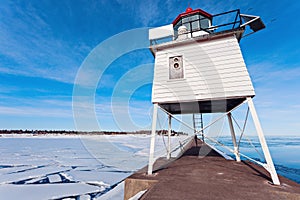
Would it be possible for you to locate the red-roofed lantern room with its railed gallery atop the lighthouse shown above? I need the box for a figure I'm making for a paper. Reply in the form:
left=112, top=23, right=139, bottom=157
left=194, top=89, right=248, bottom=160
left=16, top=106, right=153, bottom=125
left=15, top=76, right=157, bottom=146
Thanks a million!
left=149, top=7, right=265, bottom=45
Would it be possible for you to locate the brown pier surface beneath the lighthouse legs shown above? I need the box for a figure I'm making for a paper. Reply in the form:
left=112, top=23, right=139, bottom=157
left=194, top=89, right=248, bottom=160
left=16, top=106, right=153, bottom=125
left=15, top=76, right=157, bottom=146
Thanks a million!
left=124, top=141, right=300, bottom=200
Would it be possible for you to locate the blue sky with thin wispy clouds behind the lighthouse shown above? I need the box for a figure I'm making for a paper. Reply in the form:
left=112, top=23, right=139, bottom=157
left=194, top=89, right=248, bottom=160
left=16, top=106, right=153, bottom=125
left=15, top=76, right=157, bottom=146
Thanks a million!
left=0, top=0, right=300, bottom=135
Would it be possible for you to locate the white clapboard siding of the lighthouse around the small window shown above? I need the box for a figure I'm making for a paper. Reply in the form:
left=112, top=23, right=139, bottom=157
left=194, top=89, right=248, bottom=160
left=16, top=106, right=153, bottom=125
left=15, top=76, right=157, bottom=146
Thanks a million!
left=152, top=36, right=255, bottom=103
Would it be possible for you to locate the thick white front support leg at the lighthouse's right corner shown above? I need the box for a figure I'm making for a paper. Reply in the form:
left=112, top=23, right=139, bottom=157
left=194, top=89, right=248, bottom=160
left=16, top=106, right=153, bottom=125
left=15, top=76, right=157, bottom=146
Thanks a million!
left=247, top=97, right=280, bottom=185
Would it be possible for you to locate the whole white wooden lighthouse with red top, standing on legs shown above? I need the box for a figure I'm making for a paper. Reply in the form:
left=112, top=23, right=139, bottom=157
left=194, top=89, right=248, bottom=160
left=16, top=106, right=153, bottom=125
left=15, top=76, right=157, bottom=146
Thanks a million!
left=148, top=8, right=280, bottom=185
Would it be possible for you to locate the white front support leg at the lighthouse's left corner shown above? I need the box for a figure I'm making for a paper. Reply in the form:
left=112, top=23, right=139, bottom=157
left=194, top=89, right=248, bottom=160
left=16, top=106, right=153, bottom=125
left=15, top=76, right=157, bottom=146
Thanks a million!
left=148, top=103, right=158, bottom=175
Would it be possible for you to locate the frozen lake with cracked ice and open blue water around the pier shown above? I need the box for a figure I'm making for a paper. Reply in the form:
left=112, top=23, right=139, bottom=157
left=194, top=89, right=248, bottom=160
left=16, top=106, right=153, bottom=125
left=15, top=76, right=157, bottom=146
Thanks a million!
left=0, top=135, right=300, bottom=200
